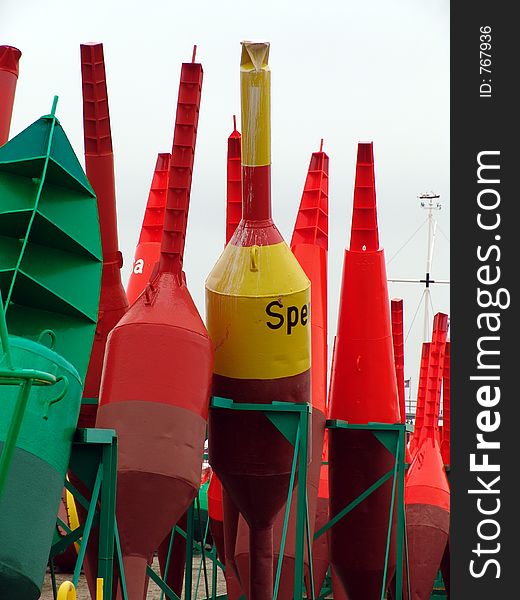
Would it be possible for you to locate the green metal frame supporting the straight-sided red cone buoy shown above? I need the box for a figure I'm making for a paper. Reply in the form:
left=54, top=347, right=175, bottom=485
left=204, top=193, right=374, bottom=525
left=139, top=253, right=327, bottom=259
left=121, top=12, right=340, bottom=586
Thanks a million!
left=314, top=419, right=413, bottom=600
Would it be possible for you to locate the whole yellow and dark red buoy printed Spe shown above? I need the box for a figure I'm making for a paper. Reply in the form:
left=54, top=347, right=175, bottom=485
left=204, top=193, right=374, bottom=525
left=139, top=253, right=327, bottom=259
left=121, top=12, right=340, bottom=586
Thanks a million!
left=206, top=42, right=311, bottom=600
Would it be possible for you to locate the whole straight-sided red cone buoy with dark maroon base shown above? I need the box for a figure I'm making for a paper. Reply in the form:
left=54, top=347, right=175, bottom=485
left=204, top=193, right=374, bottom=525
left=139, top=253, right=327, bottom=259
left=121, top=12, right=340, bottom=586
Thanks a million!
left=329, top=143, right=400, bottom=600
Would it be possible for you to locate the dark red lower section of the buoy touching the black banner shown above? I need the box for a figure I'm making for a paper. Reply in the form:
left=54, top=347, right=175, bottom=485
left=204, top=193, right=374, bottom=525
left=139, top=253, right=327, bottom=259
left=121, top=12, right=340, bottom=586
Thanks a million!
left=406, top=504, right=450, bottom=600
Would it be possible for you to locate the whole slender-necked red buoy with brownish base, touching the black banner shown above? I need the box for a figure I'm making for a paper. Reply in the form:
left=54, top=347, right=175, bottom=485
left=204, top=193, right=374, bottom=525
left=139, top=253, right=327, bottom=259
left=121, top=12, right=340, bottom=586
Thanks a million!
left=405, top=313, right=450, bottom=600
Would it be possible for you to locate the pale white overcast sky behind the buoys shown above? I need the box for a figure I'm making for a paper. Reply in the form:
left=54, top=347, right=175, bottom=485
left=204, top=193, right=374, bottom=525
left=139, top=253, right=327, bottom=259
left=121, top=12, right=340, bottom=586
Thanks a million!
left=0, top=0, right=450, bottom=404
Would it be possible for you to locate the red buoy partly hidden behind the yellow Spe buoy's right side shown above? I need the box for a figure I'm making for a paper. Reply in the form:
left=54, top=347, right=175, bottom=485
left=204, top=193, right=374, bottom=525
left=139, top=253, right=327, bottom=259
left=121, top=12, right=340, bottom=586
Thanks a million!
left=235, top=143, right=329, bottom=600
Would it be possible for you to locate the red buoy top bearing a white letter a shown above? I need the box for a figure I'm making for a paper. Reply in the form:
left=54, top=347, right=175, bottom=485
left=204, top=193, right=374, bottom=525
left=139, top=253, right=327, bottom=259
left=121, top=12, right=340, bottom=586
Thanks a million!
left=126, top=153, right=171, bottom=305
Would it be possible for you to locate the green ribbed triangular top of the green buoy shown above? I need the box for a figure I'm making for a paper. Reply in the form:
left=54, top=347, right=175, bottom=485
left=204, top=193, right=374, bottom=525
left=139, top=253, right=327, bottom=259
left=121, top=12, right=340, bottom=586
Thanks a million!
left=0, top=98, right=103, bottom=379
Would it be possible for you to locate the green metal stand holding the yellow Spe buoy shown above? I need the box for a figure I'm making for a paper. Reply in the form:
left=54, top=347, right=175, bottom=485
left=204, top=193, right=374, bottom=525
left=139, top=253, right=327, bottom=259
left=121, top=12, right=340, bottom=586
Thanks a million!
left=210, top=396, right=314, bottom=600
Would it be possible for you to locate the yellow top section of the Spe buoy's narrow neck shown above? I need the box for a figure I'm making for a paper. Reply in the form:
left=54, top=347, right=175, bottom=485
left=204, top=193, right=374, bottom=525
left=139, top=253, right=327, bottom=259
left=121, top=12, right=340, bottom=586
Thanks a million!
left=240, top=42, right=271, bottom=167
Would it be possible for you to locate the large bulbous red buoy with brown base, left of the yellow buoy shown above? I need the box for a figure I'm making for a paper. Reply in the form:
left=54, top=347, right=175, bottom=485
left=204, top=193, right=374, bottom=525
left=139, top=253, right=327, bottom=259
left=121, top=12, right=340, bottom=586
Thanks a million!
left=96, top=52, right=213, bottom=600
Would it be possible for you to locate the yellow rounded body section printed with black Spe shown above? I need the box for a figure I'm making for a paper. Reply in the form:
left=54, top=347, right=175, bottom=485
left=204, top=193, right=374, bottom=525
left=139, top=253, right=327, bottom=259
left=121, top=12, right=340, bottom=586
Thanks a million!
left=206, top=242, right=311, bottom=379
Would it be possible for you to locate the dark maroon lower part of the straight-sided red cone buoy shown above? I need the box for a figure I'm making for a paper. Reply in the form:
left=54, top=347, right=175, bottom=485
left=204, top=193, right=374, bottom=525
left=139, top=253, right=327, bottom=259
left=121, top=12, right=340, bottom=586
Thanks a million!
left=329, top=429, right=396, bottom=600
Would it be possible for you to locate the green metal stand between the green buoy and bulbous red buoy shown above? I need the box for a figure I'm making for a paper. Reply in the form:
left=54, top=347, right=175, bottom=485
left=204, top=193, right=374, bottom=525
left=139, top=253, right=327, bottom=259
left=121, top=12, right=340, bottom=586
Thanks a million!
left=49, top=429, right=121, bottom=600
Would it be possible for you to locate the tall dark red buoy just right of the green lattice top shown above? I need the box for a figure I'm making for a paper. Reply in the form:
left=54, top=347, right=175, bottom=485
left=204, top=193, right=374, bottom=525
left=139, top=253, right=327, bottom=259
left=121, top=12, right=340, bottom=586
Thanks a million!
left=78, top=44, right=128, bottom=427
